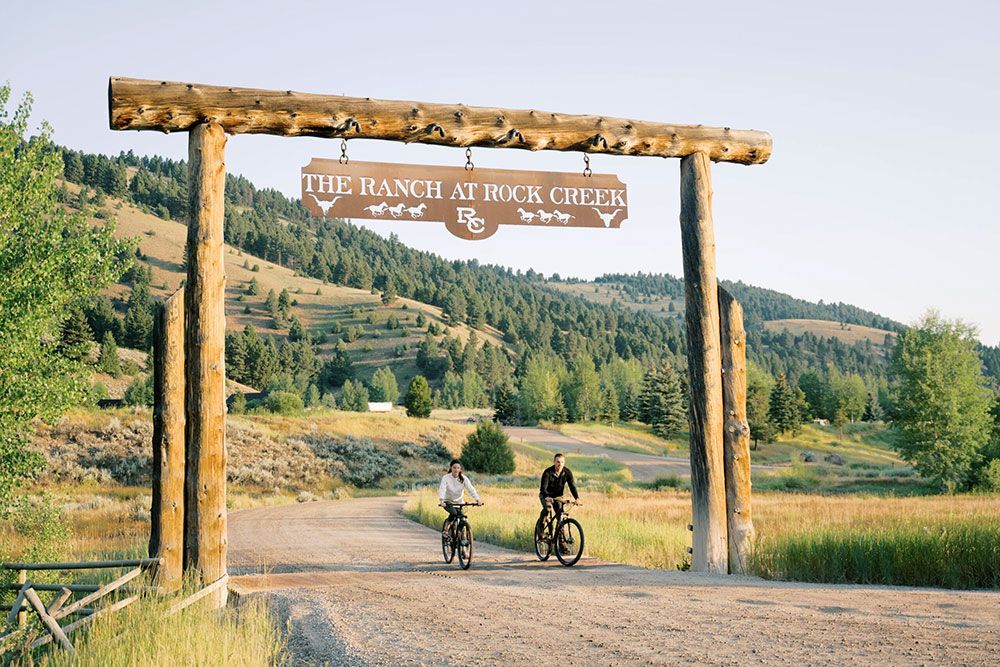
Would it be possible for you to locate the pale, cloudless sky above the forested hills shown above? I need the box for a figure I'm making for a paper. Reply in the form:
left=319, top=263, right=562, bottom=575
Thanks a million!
left=7, top=0, right=1000, bottom=345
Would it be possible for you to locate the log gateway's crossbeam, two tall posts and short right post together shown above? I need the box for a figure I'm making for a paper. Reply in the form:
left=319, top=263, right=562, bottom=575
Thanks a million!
left=108, top=77, right=771, bottom=605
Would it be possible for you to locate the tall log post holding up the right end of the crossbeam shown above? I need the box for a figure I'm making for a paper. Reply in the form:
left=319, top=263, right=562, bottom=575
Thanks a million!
left=680, top=153, right=729, bottom=574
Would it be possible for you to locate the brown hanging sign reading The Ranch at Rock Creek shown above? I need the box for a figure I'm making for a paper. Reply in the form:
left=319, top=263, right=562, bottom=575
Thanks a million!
left=302, top=158, right=628, bottom=240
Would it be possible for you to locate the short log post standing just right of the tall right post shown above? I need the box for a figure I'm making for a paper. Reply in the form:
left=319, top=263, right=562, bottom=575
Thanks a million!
left=719, top=287, right=756, bottom=574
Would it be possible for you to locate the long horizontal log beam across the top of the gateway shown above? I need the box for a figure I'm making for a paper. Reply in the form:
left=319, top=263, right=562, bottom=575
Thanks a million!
left=108, top=77, right=771, bottom=164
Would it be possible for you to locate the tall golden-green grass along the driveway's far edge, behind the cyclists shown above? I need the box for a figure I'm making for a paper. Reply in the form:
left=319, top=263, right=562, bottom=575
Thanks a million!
left=406, top=487, right=1000, bottom=588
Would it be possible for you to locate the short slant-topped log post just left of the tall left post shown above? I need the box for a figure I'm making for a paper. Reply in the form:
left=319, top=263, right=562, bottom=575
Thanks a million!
left=149, top=287, right=185, bottom=591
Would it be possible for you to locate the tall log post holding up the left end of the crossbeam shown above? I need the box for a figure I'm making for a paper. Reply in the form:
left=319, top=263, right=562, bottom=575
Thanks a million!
left=184, top=122, right=227, bottom=607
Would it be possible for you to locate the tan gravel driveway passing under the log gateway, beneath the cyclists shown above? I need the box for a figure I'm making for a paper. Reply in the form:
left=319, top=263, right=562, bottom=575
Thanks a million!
left=229, top=497, right=1000, bottom=665
